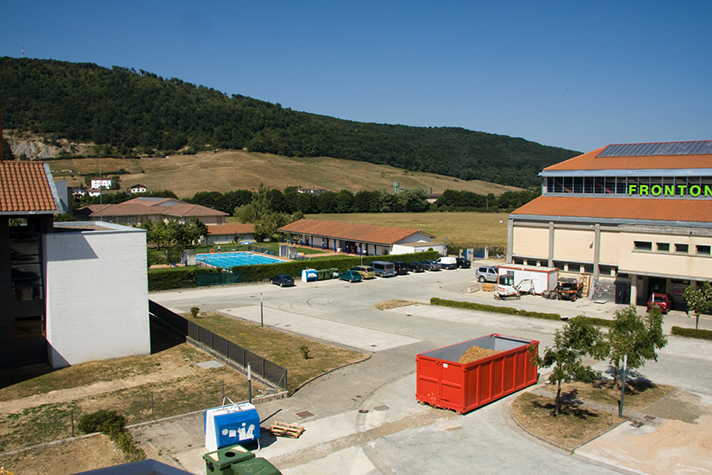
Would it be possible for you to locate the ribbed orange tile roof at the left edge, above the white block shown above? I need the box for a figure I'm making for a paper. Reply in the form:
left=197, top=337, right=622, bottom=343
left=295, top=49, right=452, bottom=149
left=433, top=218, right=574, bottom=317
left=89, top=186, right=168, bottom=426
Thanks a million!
left=0, top=161, right=59, bottom=214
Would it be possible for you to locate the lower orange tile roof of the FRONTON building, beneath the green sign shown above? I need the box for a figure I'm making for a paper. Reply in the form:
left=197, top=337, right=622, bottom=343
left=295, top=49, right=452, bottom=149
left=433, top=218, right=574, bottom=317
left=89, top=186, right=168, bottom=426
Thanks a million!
left=512, top=196, right=712, bottom=223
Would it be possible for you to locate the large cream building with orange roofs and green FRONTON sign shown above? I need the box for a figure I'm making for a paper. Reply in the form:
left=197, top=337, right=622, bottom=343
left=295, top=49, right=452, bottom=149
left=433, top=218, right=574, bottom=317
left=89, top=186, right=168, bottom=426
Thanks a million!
left=507, top=140, right=712, bottom=309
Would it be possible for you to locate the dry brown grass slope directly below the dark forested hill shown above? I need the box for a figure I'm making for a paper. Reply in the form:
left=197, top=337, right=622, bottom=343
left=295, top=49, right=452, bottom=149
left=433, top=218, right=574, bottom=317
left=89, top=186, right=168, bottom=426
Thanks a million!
left=48, top=150, right=518, bottom=198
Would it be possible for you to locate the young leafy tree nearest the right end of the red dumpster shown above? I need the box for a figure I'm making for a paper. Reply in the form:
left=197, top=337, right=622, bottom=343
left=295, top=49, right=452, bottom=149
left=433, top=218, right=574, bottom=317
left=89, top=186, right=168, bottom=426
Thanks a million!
left=536, top=317, right=609, bottom=416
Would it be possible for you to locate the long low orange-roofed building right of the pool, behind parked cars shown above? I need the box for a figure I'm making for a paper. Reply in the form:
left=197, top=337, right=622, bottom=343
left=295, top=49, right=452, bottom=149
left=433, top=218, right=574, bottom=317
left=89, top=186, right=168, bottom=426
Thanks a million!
left=279, top=219, right=447, bottom=256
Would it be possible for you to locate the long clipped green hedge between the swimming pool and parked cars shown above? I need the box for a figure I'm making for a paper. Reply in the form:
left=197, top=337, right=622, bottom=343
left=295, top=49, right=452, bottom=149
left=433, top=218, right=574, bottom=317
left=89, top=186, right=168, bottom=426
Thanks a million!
left=148, top=251, right=438, bottom=292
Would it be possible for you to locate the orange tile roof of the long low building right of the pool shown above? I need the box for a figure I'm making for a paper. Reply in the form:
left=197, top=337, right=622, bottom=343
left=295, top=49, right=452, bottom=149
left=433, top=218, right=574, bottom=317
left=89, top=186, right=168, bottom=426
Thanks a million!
left=279, top=219, right=434, bottom=244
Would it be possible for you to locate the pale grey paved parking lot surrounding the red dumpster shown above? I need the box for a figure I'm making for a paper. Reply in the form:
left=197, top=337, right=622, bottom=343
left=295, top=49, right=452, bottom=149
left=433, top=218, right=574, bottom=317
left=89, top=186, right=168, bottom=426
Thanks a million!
left=147, top=264, right=712, bottom=474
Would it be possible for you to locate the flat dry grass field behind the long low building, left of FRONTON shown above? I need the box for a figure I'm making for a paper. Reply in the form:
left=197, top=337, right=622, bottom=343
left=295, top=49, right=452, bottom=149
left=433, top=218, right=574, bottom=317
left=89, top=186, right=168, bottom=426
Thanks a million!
left=306, top=212, right=508, bottom=249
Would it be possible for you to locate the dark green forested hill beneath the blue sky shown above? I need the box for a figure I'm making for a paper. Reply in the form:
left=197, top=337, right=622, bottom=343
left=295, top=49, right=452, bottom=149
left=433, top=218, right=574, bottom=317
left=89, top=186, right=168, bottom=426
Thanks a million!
left=0, top=57, right=578, bottom=187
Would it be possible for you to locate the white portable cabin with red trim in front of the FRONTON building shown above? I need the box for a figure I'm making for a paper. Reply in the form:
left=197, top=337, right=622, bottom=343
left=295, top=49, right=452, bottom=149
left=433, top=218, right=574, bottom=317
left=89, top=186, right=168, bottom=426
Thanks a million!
left=494, top=264, right=559, bottom=299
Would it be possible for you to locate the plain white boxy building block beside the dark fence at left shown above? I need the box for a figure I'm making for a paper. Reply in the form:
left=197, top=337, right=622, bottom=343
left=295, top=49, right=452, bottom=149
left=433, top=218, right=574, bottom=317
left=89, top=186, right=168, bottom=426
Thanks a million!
left=44, top=223, right=151, bottom=368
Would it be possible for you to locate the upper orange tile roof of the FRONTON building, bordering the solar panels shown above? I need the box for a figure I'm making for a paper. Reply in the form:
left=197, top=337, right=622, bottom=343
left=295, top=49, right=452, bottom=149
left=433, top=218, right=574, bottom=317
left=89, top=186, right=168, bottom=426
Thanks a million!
left=544, top=147, right=712, bottom=172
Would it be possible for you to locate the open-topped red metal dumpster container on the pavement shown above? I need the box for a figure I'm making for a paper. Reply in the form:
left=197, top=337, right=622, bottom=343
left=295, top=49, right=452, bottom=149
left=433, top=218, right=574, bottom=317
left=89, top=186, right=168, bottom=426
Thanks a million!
left=415, top=333, right=539, bottom=414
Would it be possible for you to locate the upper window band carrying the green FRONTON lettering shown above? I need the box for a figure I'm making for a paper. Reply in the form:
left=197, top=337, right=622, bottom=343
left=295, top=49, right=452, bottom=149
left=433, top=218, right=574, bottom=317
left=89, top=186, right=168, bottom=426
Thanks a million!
left=543, top=176, right=712, bottom=198
